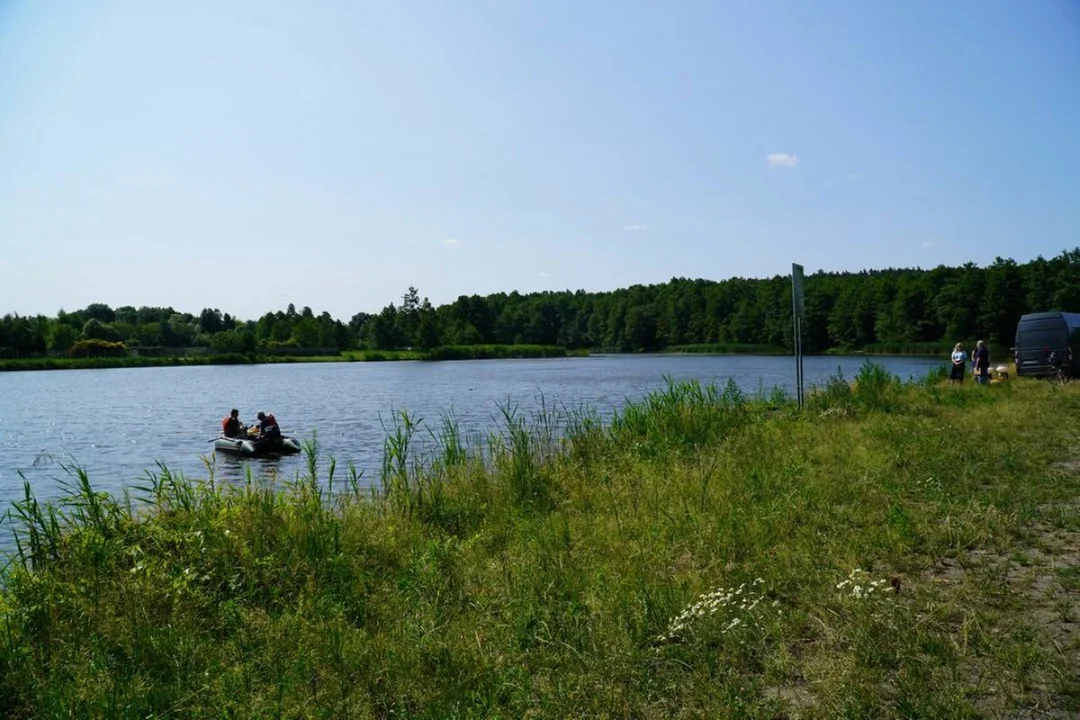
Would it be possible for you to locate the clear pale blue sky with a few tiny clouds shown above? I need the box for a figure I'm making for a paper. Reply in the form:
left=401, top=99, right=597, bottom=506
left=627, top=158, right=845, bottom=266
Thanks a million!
left=0, top=0, right=1080, bottom=318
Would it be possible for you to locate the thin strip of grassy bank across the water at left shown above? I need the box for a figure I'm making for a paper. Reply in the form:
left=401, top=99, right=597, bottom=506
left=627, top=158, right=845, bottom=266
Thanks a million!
left=0, top=345, right=589, bottom=371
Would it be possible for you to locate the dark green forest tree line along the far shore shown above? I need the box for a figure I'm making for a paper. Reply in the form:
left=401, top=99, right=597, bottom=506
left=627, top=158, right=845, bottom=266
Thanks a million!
left=0, top=248, right=1080, bottom=357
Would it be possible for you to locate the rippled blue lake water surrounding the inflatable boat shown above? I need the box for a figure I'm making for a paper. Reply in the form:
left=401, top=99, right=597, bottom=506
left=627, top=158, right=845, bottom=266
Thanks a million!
left=0, top=355, right=942, bottom=511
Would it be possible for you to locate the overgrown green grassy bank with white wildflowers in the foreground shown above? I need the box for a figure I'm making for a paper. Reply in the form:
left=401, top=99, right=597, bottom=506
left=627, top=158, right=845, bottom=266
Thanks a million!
left=0, top=366, right=1080, bottom=718
